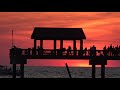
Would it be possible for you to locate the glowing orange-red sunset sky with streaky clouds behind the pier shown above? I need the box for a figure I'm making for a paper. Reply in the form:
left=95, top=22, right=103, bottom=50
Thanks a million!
left=0, top=12, right=120, bottom=67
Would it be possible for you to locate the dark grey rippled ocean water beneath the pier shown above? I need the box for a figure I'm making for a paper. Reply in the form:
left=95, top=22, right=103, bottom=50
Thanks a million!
left=0, top=66, right=120, bottom=78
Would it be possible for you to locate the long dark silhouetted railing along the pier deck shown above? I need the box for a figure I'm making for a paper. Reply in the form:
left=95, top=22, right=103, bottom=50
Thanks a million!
left=10, top=48, right=120, bottom=56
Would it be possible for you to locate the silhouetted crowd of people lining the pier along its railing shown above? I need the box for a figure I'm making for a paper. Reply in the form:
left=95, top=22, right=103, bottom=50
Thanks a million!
left=10, top=44, right=120, bottom=56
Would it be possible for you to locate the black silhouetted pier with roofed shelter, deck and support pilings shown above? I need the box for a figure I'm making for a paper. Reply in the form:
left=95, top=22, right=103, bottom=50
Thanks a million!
left=10, top=27, right=120, bottom=78
